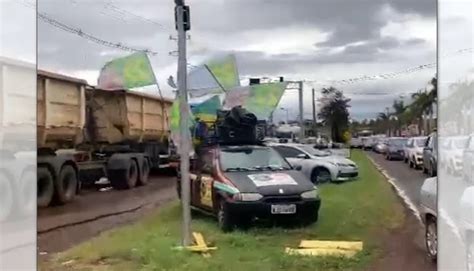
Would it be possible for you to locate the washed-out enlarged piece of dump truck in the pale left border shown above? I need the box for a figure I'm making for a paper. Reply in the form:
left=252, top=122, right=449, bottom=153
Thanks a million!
left=0, top=57, right=36, bottom=221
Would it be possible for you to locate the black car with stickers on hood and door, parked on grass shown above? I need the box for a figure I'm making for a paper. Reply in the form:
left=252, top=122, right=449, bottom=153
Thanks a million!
left=178, top=145, right=321, bottom=231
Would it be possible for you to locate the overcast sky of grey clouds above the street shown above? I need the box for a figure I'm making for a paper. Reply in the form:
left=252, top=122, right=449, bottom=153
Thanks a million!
left=38, top=0, right=436, bottom=120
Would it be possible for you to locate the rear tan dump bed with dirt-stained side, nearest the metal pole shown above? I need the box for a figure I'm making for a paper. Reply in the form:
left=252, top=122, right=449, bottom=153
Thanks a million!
left=87, top=89, right=172, bottom=144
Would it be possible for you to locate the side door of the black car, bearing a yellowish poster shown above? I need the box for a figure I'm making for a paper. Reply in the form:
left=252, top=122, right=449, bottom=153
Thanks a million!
left=191, top=149, right=215, bottom=210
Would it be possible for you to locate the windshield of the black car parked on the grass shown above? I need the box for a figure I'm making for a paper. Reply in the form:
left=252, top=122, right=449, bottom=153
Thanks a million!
left=220, top=147, right=291, bottom=171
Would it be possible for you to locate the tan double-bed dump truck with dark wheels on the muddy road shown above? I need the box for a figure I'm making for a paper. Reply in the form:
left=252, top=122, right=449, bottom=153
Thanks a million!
left=37, top=70, right=172, bottom=207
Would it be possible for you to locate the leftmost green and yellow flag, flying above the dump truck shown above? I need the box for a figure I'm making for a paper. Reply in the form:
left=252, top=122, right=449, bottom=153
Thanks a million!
left=97, top=52, right=156, bottom=90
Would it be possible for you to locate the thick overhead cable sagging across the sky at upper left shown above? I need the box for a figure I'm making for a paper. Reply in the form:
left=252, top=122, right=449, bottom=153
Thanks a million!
left=37, top=12, right=158, bottom=55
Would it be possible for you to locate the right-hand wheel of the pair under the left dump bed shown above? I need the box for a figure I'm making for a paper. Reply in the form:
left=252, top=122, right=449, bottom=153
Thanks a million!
left=54, top=165, right=78, bottom=204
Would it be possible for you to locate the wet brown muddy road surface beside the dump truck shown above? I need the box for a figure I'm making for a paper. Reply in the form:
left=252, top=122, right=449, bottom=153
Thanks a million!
left=37, top=171, right=177, bottom=256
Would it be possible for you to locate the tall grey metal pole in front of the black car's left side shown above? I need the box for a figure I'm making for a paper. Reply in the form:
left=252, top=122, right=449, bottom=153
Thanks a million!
left=176, top=1, right=191, bottom=246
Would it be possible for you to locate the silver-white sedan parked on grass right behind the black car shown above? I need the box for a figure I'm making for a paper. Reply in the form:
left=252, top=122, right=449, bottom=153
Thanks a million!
left=272, top=144, right=359, bottom=184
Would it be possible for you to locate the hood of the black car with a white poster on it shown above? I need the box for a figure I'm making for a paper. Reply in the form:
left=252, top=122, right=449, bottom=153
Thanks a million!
left=224, top=170, right=314, bottom=196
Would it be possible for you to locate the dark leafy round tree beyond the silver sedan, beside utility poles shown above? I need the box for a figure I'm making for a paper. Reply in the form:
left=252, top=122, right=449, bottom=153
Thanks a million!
left=318, top=87, right=351, bottom=142
